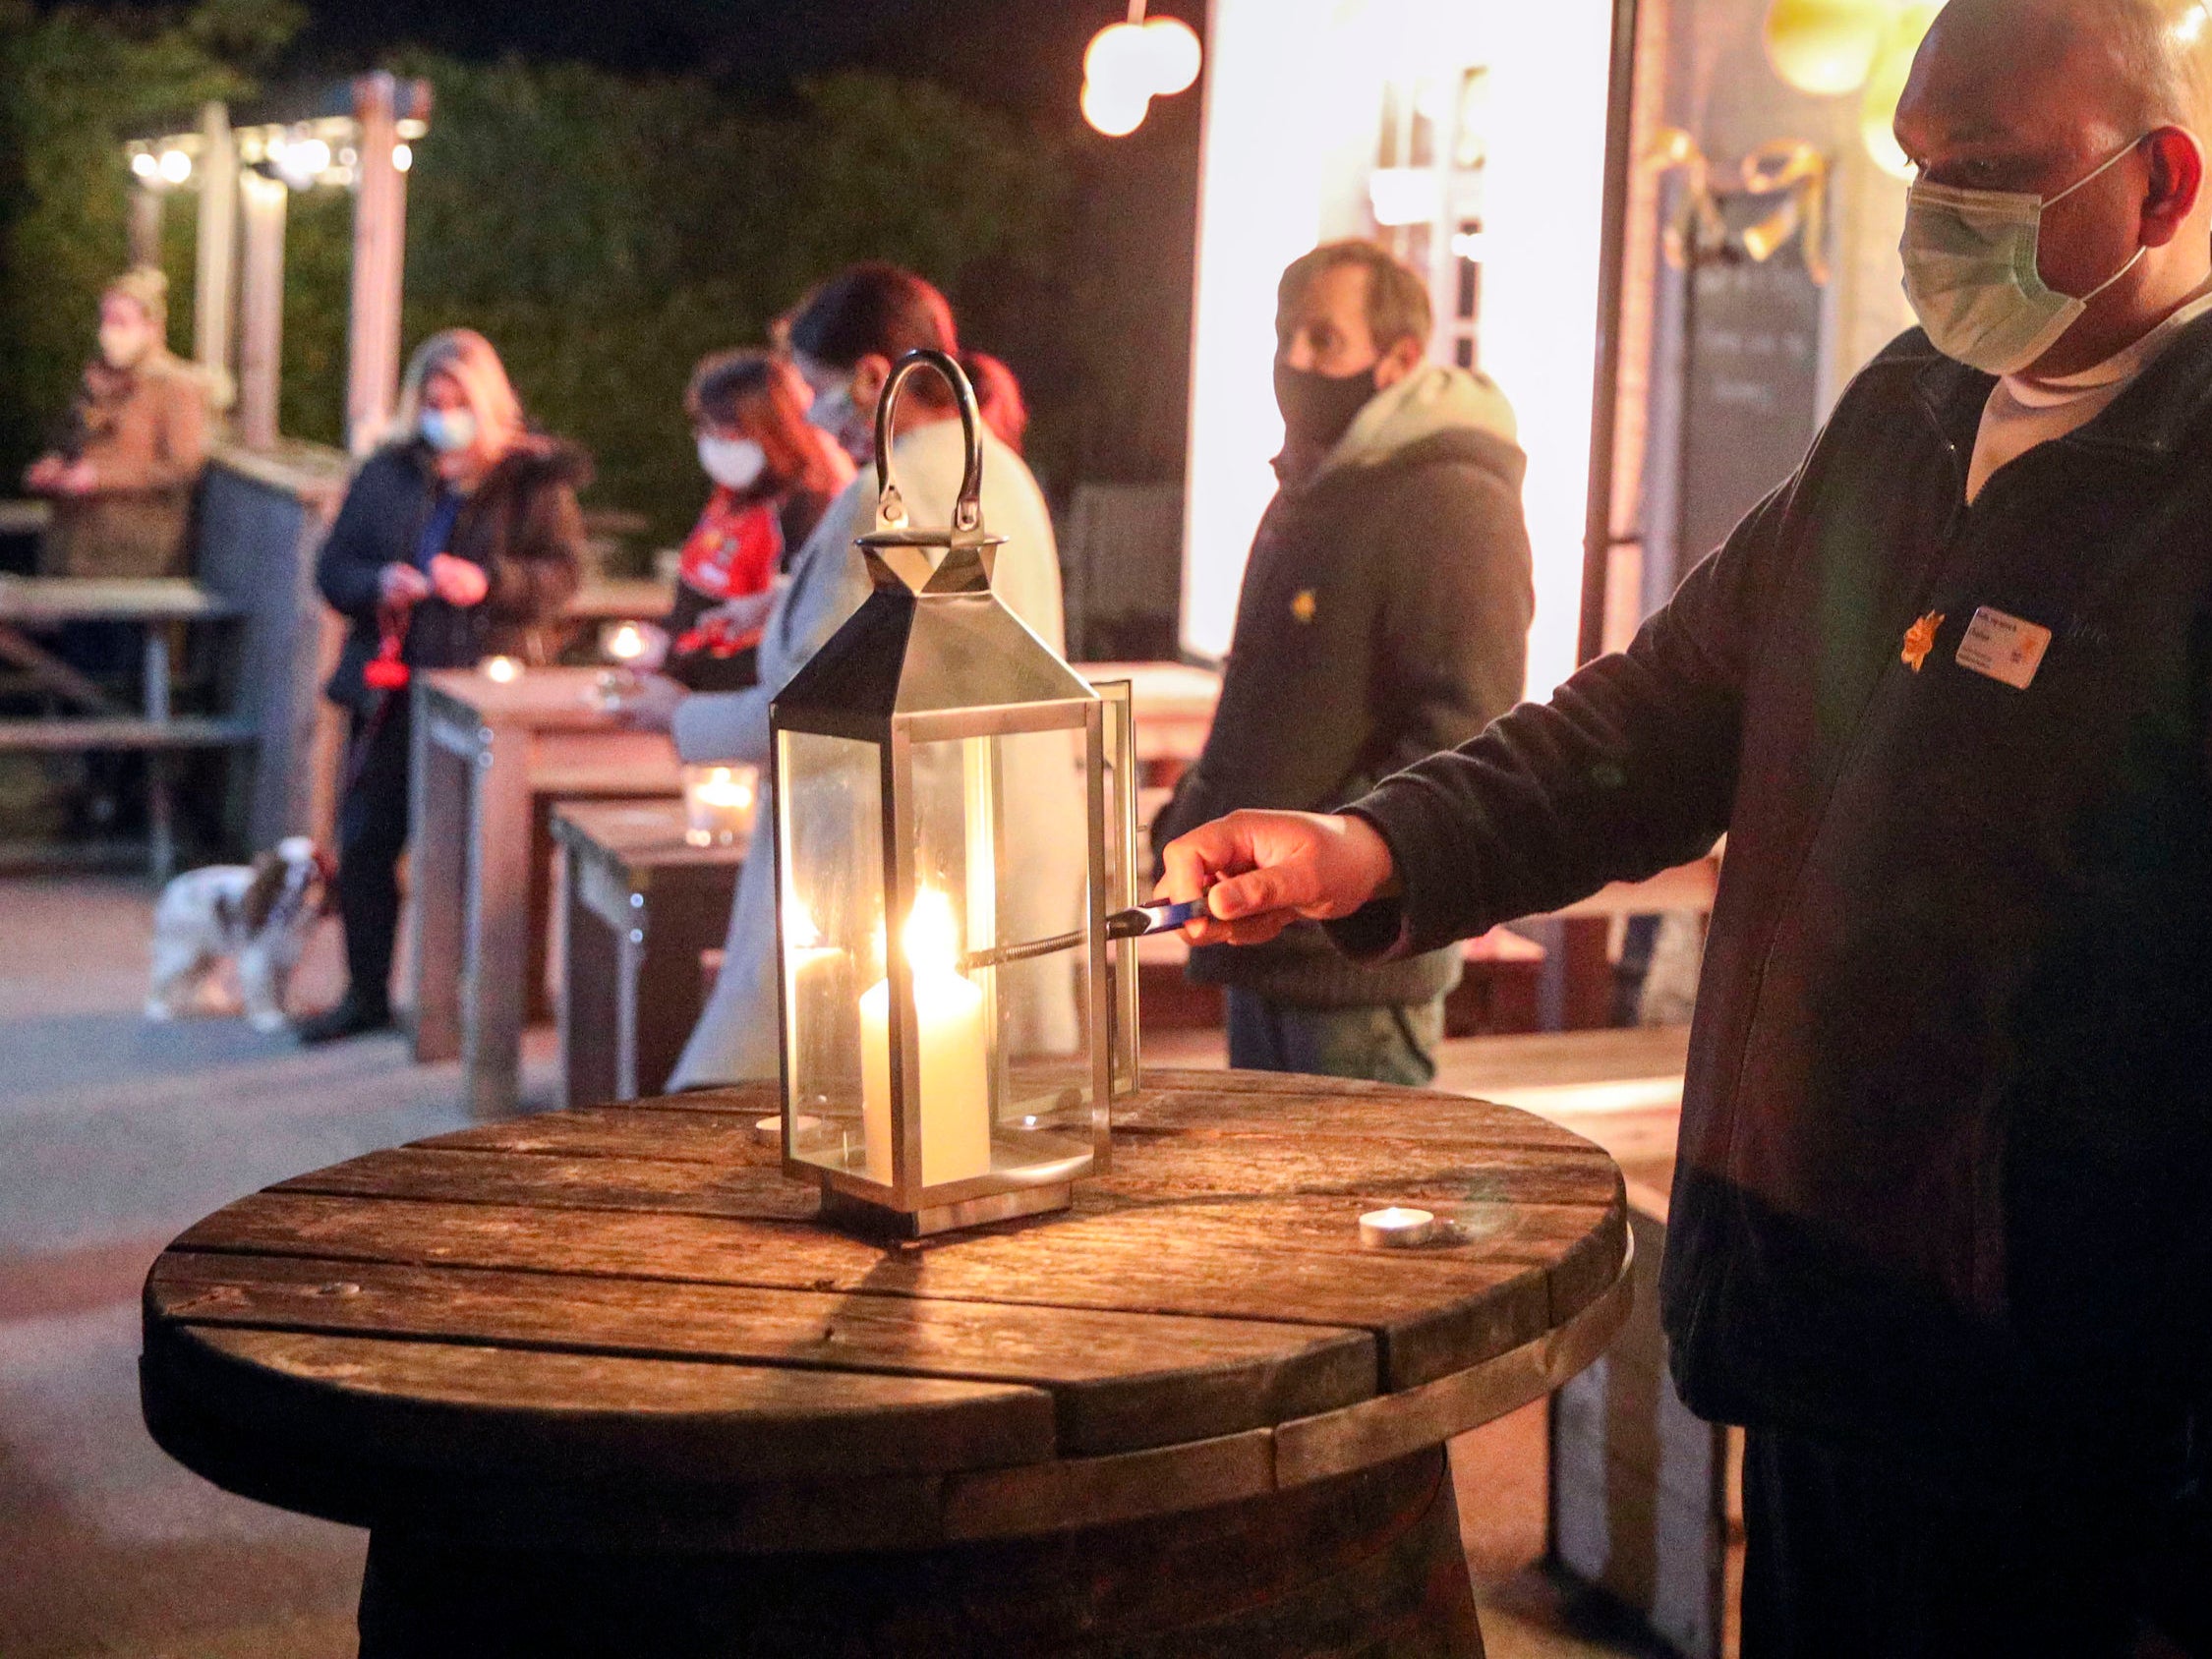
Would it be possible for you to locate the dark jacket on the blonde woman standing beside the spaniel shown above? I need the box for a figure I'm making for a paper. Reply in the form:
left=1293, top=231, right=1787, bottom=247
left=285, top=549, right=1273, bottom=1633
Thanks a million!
left=315, top=435, right=591, bottom=710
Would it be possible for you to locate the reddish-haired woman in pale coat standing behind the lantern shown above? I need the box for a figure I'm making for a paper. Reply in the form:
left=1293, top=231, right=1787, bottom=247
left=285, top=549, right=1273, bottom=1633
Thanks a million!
left=639, top=263, right=1066, bottom=1088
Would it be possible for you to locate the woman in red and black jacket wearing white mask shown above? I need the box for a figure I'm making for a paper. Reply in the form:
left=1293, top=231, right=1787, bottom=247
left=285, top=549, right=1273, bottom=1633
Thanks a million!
left=666, top=352, right=851, bottom=690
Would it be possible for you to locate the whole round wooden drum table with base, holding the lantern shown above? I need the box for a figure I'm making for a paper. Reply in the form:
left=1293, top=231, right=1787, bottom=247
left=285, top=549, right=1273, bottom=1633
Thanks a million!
left=142, top=1073, right=1628, bottom=1659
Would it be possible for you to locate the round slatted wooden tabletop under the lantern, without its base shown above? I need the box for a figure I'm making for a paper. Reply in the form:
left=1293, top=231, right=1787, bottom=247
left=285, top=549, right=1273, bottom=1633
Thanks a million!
left=146, top=1073, right=1628, bottom=1548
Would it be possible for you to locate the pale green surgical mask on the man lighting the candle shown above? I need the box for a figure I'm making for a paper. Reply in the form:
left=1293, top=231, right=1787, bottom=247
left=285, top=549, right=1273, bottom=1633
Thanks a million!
left=1900, top=140, right=2148, bottom=373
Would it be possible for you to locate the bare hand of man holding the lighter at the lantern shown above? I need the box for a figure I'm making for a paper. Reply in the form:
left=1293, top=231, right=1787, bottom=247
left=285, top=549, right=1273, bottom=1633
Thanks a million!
left=1155, top=812, right=1394, bottom=944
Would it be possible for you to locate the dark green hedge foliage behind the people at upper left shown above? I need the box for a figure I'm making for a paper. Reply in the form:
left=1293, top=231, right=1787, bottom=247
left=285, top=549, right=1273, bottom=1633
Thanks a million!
left=0, top=0, right=1071, bottom=552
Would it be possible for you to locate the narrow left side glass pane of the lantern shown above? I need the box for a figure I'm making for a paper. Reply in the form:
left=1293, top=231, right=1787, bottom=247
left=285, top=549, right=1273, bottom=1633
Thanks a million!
left=777, top=730, right=892, bottom=1181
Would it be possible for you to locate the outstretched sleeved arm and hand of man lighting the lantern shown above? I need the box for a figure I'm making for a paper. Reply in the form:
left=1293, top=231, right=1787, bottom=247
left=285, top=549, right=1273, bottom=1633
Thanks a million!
left=1159, top=486, right=1792, bottom=955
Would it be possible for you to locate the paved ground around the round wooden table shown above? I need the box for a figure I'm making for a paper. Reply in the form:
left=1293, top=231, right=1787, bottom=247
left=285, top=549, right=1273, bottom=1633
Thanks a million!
left=0, top=879, right=1646, bottom=1659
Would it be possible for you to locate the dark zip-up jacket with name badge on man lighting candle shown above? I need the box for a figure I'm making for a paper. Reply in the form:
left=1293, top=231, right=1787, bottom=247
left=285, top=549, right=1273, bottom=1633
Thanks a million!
left=1336, top=318, right=2212, bottom=1477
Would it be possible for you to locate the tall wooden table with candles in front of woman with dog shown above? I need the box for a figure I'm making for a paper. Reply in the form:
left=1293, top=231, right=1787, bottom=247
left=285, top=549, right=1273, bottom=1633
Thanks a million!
left=409, top=668, right=681, bottom=1117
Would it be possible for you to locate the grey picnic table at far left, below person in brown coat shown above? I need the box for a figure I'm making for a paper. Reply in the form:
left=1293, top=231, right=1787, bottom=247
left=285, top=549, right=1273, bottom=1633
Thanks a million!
left=0, top=575, right=255, bottom=881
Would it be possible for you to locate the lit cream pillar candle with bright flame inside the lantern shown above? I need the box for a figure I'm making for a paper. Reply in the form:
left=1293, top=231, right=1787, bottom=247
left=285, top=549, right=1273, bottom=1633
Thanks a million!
left=860, top=887, right=991, bottom=1185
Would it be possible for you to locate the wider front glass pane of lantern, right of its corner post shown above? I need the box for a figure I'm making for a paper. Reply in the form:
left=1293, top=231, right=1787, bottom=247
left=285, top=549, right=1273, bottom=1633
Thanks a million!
left=909, top=725, right=1102, bottom=1185
